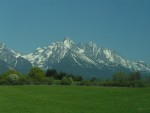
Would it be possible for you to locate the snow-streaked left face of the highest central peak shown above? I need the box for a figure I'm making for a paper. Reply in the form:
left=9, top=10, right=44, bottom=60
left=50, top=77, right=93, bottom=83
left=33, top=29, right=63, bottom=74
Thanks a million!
left=23, top=39, right=74, bottom=69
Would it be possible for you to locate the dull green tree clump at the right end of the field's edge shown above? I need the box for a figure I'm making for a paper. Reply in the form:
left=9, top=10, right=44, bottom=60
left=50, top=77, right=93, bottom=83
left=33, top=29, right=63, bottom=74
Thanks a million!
left=100, top=71, right=148, bottom=87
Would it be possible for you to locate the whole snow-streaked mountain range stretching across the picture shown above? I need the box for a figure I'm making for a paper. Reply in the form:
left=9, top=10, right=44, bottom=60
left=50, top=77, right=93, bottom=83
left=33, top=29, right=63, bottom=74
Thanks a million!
left=0, top=38, right=150, bottom=78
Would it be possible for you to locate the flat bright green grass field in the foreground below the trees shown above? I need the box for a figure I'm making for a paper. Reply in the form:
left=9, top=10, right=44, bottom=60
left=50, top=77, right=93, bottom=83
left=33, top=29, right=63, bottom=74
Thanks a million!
left=0, top=86, right=150, bottom=113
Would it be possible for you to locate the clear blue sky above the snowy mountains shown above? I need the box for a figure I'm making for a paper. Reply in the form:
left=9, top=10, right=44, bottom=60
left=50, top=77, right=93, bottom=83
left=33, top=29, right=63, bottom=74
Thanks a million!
left=0, top=0, right=150, bottom=64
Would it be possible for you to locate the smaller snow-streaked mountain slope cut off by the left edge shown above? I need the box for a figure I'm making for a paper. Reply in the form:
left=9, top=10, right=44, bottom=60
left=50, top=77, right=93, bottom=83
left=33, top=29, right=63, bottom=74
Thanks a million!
left=0, top=42, right=32, bottom=73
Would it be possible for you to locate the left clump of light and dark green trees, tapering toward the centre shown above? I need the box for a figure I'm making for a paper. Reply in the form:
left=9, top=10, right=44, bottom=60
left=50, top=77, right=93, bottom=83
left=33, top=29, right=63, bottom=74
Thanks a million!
left=0, top=67, right=83, bottom=85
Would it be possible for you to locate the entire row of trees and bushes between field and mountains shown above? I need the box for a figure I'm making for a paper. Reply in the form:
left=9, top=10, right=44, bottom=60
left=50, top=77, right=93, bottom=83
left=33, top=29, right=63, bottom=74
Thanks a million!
left=0, top=67, right=150, bottom=87
